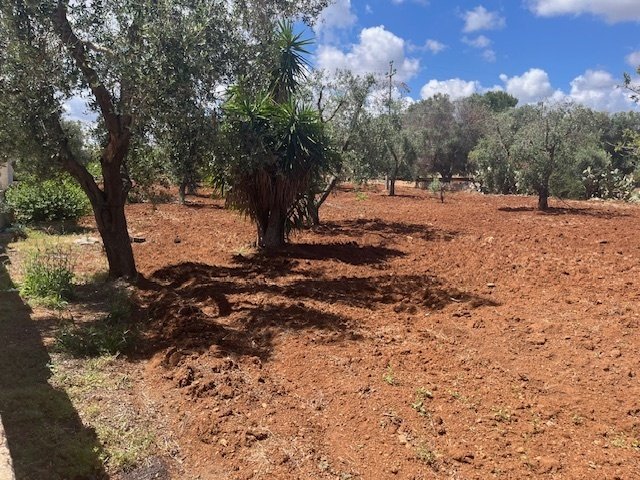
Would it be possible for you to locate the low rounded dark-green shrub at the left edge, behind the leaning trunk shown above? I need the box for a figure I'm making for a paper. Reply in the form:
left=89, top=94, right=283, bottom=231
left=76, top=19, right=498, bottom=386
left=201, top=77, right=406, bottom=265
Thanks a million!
left=5, top=178, right=90, bottom=223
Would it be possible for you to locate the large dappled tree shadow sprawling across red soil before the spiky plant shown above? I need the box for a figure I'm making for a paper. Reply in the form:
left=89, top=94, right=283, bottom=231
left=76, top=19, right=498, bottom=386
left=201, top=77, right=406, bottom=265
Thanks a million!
left=138, top=245, right=496, bottom=359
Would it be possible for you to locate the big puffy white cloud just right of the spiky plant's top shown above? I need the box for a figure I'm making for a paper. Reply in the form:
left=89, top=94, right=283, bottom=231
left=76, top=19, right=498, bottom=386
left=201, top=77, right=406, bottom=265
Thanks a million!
left=316, top=25, right=420, bottom=82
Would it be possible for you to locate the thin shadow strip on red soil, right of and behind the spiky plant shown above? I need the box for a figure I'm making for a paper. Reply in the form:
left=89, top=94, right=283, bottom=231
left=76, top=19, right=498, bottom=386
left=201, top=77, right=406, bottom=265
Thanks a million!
left=314, top=218, right=458, bottom=241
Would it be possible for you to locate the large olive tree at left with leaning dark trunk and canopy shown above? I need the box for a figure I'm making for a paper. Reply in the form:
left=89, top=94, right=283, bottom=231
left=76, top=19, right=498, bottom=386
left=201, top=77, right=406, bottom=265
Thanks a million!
left=0, top=0, right=326, bottom=277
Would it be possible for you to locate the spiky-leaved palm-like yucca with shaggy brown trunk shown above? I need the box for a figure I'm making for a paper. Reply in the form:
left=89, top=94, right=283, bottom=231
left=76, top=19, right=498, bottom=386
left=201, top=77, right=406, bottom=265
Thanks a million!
left=224, top=22, right=332, bottom=247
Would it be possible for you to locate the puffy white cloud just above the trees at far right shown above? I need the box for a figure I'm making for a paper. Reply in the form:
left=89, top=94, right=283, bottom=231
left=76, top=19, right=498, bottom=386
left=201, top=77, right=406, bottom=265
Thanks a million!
left=569, top=70, right=635, bottom=112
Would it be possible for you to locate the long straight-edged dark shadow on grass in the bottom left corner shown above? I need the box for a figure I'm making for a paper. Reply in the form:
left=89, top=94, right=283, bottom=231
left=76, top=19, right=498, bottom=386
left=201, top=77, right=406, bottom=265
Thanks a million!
left=0, top=235, right=106, bottom=480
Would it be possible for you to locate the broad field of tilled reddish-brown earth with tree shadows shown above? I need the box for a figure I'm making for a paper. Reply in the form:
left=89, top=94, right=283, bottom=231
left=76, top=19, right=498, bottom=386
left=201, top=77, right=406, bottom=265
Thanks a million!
left=128, top=188, right=640, bottom=480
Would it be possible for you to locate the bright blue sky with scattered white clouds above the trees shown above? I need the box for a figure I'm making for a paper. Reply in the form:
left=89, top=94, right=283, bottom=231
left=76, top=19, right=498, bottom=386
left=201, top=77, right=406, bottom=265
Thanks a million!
left=309, top=0, right=640, bottom=111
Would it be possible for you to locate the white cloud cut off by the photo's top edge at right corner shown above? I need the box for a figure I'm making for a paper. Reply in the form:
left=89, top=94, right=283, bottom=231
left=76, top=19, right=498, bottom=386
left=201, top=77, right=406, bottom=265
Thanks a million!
left=529, top=0, right=640, bottom=22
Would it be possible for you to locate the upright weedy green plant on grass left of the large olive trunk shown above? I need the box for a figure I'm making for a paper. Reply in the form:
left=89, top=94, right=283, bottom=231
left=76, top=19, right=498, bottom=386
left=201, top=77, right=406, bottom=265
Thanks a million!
left=20, top=246, right=74, bottom=307
